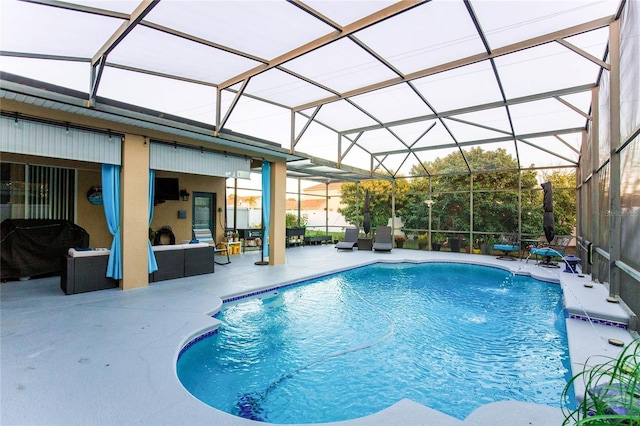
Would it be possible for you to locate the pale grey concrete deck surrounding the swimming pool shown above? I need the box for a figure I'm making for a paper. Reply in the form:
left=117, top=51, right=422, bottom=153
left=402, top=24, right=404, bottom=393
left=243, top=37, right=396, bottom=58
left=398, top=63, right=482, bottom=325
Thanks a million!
left=0, top=246, right=633, bottom=425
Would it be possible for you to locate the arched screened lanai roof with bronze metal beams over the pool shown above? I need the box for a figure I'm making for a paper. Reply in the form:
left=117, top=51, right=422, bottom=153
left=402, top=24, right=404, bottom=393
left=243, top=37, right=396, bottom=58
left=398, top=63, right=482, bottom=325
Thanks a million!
left=0, top=0, right=624, bottom=180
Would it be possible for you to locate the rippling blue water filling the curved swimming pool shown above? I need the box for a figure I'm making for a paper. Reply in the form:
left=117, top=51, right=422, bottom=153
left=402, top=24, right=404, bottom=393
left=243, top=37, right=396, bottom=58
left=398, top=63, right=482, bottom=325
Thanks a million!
left=177, top=263, right=570, bottom=424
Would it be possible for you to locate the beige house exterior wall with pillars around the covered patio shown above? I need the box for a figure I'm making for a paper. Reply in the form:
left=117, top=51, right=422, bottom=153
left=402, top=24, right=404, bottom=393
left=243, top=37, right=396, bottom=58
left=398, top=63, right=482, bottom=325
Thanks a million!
left=0, top=100, right=286, bottom=289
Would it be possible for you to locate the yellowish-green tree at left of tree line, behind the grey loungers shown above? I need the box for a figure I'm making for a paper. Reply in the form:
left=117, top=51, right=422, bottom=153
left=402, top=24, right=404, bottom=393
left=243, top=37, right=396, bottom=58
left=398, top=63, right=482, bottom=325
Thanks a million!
left=338, top=179, right=409, bottom=229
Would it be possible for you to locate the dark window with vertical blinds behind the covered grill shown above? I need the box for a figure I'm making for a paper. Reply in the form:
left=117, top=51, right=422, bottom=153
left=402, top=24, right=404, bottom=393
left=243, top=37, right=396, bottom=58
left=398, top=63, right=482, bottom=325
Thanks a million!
left=0, top=163, right=76, bottom=221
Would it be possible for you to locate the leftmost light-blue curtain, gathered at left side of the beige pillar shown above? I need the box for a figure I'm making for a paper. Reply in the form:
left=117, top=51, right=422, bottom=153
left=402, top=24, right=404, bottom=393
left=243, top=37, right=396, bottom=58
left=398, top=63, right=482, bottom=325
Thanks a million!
left=102, top=164, right=122, bottom=280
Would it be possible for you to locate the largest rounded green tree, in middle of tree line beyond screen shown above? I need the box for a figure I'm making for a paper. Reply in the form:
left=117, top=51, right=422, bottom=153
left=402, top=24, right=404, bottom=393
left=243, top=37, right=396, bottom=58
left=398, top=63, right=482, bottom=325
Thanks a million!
left=401, top=147, right=542, bottom=233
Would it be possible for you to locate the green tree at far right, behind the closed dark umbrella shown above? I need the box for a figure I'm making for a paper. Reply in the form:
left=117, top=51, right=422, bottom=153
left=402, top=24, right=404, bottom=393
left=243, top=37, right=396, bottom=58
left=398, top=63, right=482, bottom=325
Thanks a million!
left=542, top=170, right=577, bottom=235
